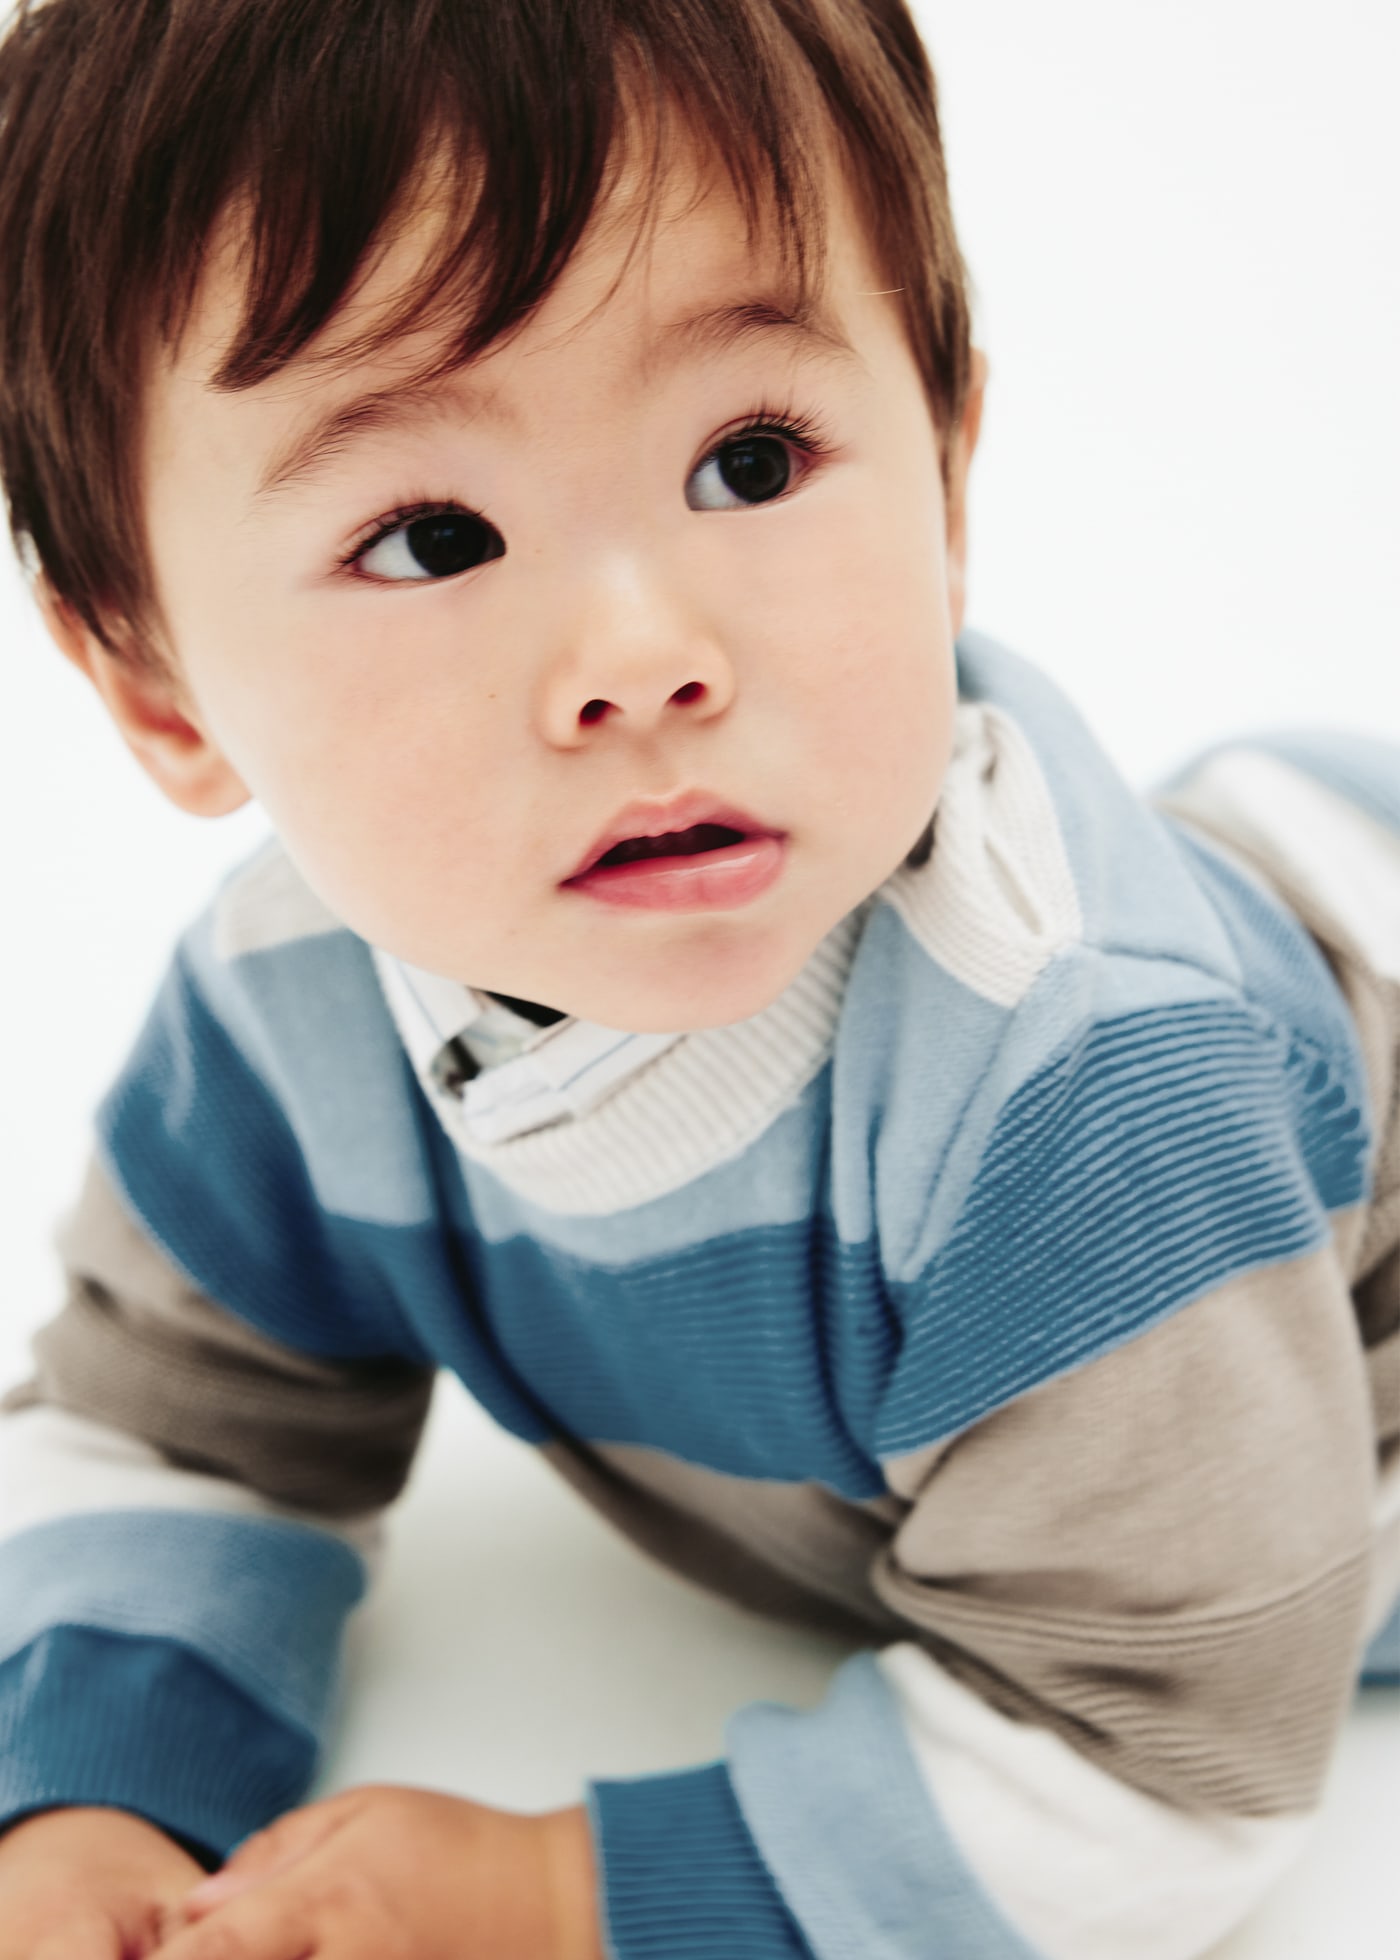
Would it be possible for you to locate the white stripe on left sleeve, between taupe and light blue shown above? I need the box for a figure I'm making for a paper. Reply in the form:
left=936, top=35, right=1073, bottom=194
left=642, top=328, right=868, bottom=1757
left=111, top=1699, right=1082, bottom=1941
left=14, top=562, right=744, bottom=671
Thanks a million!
left=0, top=1403, right=384, bottom=1580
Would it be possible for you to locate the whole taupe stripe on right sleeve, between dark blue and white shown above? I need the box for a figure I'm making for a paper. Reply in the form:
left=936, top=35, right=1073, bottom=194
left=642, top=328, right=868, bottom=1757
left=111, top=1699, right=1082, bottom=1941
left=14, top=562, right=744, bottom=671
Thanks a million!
left=875, top=1250, right=1376, bottom=1815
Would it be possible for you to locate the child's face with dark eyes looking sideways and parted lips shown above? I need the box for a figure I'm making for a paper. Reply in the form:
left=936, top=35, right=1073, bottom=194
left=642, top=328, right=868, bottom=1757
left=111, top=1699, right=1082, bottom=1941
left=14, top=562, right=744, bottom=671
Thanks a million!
left=54, top=142, right=975, bottom=1031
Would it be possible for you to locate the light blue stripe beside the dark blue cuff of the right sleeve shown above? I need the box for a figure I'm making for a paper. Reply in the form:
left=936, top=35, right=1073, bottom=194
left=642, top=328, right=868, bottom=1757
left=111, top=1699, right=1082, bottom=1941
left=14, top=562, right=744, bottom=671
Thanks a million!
left=725, top=1654, right=1037, bottom=1960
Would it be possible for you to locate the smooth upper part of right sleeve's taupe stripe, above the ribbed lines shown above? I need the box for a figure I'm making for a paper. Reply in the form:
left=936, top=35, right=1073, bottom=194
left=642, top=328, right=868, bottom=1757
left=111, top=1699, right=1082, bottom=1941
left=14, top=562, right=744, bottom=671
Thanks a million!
left=884, top=1249, right=1376, bottom=1613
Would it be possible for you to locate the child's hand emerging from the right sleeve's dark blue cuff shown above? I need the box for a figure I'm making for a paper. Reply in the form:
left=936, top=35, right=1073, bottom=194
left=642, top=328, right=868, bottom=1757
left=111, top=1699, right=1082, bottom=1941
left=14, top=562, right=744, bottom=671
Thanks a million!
left=151, top=1784, right=602, bottom=1960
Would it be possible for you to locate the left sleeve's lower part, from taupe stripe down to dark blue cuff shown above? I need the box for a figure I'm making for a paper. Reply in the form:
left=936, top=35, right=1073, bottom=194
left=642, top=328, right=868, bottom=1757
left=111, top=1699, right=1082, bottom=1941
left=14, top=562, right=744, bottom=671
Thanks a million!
left=0, top=1128, right=431, bottom=1862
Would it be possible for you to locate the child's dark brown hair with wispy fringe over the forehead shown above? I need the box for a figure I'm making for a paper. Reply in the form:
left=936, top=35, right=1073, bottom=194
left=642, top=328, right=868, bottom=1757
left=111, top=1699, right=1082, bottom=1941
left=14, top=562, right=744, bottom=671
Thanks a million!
left=0, top=0, right=971, bottom=666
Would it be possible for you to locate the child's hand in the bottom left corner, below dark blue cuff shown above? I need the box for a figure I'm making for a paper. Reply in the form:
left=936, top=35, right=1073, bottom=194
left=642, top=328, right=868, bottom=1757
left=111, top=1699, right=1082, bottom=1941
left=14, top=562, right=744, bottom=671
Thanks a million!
left=0, top=1805, right=204, bottom=1960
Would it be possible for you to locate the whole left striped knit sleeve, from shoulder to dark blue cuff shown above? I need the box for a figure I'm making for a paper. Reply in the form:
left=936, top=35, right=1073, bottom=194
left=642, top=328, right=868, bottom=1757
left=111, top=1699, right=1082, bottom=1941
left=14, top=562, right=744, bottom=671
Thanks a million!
left=0, top=854, right=433, bottom=1862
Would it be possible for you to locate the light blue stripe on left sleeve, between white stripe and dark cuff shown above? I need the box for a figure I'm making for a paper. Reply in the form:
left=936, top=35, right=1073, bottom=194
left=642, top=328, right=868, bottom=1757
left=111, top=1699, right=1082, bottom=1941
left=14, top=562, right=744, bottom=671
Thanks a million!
left=0, top=1511, right=365, bottom=1739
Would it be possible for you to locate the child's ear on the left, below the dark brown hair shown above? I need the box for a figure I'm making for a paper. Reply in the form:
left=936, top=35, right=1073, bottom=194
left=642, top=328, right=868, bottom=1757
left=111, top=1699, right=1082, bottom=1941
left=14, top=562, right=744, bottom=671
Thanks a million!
left=33, top=576, right=251, bottom=817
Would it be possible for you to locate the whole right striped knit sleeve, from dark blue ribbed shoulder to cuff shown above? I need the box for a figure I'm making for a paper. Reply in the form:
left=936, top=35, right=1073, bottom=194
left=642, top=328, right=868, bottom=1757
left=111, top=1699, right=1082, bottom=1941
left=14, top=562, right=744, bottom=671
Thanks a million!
left=594, top=940, right=1394, bottom=1960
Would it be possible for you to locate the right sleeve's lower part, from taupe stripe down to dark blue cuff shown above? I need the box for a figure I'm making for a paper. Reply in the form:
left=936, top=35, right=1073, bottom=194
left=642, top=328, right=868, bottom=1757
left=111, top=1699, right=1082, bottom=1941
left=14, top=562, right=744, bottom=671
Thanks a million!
left=576, top=1252, right=1375, bottom=1960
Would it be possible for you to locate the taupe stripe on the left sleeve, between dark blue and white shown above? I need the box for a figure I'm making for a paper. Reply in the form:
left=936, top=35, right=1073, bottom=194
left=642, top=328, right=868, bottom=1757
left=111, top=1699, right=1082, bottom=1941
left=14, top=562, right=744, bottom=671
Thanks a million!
left=0, top=1158, right=433, bottom=1517
